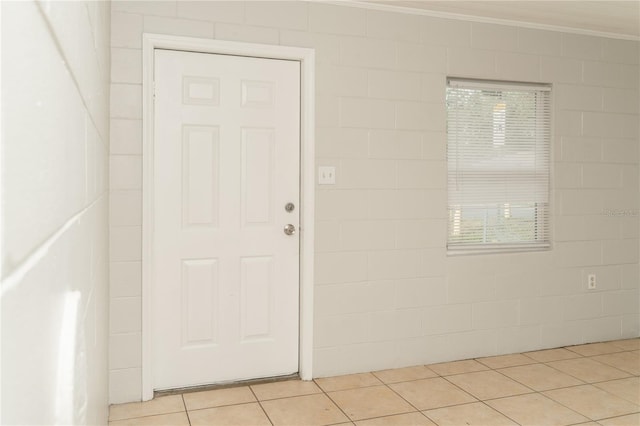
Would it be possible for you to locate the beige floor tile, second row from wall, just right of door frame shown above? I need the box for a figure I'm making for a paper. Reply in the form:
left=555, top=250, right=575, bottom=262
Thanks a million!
left=328, top=382, right=416, bottom=420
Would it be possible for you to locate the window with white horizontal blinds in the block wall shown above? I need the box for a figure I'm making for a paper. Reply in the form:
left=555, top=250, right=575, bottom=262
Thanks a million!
left=446, top=78, right=551, bottom=252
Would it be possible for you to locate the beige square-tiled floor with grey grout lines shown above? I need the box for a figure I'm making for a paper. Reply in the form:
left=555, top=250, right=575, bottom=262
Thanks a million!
left=109, top=339, right=640, bottom=426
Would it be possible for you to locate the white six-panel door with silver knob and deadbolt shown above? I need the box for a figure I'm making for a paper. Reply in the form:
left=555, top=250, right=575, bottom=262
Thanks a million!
left=152, top=50, right=300, bottom=389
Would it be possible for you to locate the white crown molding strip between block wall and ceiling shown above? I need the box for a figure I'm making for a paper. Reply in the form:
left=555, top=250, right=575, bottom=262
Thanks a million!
left=311, top=0, right=640, bottom=41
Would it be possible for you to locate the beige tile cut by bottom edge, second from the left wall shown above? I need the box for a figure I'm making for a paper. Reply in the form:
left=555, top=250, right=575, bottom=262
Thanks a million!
left=189, top=402, right=271, bottom=426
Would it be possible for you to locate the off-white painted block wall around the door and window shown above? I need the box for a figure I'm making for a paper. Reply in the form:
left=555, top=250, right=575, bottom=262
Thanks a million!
left=110, top=1, right=640, bottom=402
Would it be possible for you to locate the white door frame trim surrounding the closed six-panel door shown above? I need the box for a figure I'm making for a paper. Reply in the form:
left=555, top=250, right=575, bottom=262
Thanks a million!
left=142, top=33, right=315, bottom=401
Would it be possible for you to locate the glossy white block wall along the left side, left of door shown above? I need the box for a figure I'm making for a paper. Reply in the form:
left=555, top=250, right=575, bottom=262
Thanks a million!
left=0, top=1, right=110, bottom=424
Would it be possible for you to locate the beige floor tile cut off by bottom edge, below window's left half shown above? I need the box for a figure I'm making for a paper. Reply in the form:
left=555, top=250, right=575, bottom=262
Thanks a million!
left=424, top=402, right=517, bottom=426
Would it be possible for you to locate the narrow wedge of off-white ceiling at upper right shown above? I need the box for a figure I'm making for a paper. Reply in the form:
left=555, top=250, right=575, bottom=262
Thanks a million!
left=360, top=0, right=640, bottom=40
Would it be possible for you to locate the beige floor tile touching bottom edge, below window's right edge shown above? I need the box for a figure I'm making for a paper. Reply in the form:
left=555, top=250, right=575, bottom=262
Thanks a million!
left=487, top=393, right=589, bottom=426
